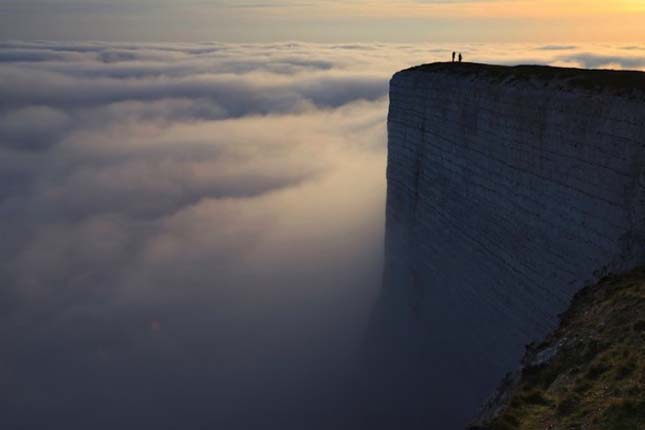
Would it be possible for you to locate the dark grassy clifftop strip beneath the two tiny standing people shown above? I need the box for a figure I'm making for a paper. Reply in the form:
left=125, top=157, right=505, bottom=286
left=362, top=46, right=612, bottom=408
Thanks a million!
left=399, top=63, right=645, bottom=96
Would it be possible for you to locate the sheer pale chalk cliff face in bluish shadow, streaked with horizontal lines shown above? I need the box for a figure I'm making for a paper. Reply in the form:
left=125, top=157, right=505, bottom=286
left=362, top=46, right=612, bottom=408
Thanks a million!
left=372, top=64, right=645, bottom=430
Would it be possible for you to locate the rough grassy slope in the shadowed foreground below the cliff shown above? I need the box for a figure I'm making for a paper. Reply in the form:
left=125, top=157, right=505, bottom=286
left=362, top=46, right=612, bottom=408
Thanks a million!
left=473, top=268, right=645, bottom=430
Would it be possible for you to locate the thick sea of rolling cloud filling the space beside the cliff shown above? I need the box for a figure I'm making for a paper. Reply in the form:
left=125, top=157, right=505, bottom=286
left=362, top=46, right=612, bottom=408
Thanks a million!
left=0, top=41, right=645, bottom=430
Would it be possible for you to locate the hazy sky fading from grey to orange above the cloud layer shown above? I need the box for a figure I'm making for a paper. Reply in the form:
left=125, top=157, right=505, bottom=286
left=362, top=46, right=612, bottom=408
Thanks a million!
left=0, top=0, right=645, bottom=42
